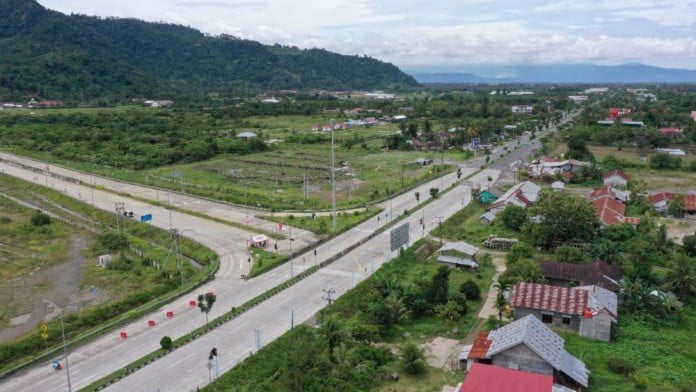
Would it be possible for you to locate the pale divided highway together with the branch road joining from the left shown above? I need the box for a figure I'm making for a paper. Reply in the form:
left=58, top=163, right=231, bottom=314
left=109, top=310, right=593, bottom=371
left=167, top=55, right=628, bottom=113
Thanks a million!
left=0, top=111, right=576, bottom=391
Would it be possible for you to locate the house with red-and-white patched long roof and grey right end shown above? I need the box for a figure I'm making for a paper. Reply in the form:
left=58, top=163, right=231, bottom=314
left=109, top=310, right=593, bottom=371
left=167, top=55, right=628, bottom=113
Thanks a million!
left=510, top=282, right=618, bottom=341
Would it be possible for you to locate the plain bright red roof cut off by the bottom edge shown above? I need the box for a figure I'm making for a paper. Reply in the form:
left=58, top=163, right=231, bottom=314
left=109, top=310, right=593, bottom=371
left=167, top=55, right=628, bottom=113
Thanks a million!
left=456, top=363, right=553, bottom=392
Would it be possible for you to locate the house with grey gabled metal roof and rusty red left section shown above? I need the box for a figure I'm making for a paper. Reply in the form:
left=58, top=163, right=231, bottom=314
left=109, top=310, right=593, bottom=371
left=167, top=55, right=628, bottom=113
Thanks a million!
left=467, top=315, right=590, bottom=389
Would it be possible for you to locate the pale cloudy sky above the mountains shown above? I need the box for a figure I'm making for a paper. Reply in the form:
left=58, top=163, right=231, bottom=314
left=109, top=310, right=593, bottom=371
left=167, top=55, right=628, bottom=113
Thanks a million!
left=38, top=0, right=696, bottom=70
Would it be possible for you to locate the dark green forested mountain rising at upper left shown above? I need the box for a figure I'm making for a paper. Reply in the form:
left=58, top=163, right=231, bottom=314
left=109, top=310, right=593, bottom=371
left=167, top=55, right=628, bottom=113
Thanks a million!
left=0, top=0, right=417, bottom=100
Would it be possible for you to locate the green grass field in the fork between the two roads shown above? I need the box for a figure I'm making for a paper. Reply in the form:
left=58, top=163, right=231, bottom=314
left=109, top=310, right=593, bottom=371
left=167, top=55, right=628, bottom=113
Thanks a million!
left=135, top=144, right=461, bottom=210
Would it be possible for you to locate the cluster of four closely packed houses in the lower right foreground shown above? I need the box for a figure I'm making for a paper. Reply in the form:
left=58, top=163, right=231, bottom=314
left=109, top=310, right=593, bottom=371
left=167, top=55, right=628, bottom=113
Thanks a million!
left=456, top=261, right=620, bottom=392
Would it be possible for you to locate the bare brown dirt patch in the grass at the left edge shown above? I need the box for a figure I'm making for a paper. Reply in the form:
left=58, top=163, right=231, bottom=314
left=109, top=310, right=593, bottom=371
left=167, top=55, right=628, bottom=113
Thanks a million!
left=0, top=235, right=94, bottom=343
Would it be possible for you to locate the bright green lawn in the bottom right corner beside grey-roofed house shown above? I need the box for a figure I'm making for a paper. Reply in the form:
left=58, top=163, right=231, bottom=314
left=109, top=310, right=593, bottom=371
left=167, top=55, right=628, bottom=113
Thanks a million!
left=561, top=304, right=696, bottom=392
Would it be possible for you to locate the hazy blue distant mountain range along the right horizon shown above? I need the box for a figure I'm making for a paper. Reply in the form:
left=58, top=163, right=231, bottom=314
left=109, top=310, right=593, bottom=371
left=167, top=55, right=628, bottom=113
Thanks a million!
left=401, top=64, right=696, bottom=83
